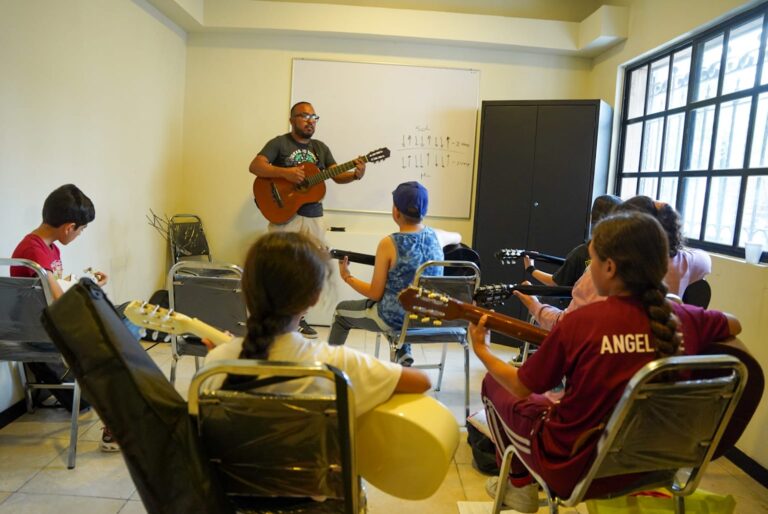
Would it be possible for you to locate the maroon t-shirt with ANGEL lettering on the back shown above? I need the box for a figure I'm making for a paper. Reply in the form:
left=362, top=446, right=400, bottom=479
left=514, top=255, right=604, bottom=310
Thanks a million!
left=518, top=296, right=730, bottom=462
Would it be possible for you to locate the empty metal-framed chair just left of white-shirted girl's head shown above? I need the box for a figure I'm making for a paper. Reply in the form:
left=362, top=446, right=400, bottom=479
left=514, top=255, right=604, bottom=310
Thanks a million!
left=166, top=261, right=247, bottom=383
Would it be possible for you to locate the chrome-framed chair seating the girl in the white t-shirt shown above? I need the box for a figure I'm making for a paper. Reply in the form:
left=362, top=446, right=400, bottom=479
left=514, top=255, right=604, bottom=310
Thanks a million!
left=188, top=360, right=364, bottom=514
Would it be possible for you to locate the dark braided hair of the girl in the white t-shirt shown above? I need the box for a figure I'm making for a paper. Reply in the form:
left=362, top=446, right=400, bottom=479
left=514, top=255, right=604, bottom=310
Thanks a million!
left=240, top=232, right=331, bottom=359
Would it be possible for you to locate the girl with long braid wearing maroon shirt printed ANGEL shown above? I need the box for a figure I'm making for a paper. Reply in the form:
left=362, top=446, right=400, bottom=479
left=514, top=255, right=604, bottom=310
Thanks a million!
left=470, top=212, right=741, bottom=512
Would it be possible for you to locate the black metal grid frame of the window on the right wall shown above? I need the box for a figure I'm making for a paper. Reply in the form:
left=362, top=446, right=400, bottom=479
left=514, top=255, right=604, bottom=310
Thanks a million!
left=614, top=2, right=768, bottom=261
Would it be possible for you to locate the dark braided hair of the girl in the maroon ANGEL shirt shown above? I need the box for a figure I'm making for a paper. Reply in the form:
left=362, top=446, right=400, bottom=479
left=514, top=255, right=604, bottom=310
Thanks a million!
left=592, top=212, right=681, bottom=357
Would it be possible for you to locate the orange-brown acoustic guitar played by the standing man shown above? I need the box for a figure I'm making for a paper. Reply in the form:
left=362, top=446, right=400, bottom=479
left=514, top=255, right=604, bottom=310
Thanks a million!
left=253, top=148, right=389, bottom=224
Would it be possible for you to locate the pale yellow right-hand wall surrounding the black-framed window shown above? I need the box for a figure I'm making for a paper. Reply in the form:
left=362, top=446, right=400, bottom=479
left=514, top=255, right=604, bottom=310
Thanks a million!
left=589, top=0, right=768, bottom=467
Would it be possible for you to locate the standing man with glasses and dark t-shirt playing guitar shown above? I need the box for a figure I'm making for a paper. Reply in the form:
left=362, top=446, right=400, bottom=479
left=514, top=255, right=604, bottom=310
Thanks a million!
left=248, top=102, right=365, bottom=338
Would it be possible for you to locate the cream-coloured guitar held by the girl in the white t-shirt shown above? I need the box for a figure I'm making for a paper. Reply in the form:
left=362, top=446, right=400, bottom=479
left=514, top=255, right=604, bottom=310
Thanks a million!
left=125, top=301, right=459, bottom=500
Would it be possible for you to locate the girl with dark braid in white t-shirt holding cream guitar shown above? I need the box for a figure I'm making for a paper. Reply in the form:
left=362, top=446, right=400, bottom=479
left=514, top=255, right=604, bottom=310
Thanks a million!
left=205, top=232, right=431, bottom=416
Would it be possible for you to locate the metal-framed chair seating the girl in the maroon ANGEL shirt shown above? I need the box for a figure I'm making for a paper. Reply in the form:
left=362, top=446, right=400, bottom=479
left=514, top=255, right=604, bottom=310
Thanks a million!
left=493, top=355, right=747, bottom=514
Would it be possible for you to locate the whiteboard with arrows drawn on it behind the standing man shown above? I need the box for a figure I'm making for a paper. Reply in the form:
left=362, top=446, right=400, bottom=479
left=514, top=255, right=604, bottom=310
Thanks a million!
left=291, top=59, right=480, bottom=218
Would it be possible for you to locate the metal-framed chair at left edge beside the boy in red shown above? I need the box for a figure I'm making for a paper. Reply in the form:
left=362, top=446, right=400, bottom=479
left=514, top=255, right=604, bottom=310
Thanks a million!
left=0, top=259, right=80, bottom=469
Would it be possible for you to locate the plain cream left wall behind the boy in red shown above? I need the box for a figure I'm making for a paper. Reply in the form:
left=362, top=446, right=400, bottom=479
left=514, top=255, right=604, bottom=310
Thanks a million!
left=0, top=0, right=186, bottom=411
